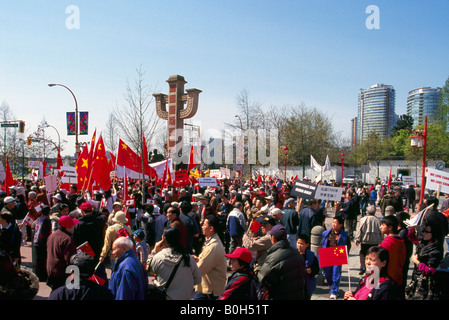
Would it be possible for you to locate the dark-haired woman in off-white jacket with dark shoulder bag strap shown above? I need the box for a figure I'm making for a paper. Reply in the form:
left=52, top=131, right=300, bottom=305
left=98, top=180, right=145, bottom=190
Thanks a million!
left=147, top=226, right=201, bottom=300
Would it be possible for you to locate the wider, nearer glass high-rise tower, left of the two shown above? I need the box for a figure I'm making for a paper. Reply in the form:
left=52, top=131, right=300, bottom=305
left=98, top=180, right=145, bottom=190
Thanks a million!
left=356, top=84, right=397, bottom=143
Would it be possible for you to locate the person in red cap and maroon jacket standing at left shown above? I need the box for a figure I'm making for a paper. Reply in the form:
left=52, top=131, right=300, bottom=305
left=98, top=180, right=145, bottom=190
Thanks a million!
left=47, top=216, right=78, bottom=290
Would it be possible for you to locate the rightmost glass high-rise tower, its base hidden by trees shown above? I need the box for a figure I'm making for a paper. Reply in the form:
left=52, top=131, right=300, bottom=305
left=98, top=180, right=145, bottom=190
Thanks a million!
left=407, top=87, right=441, bottom=127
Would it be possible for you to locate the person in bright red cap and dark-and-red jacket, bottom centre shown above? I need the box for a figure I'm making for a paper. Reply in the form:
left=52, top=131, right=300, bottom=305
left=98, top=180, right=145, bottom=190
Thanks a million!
left=218, top=247, right=257, bottom=300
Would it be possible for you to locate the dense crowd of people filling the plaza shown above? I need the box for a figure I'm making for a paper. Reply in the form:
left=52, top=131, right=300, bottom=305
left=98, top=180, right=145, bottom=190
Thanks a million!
left=0, top=178, right=449, bottom=300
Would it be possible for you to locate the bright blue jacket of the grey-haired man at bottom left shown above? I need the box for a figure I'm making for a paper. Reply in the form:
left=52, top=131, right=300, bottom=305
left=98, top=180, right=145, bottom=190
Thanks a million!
left=109, top=250, right=148, bottom=300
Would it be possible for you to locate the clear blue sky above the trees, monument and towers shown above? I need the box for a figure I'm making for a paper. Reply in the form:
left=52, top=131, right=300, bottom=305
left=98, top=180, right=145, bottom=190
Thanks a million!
left=0, top=0, right=449, bottom=154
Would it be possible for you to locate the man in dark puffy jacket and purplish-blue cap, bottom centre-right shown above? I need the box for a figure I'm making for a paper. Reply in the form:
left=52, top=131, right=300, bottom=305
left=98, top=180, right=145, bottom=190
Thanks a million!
left=257, top=224, right=306, bottom=300
